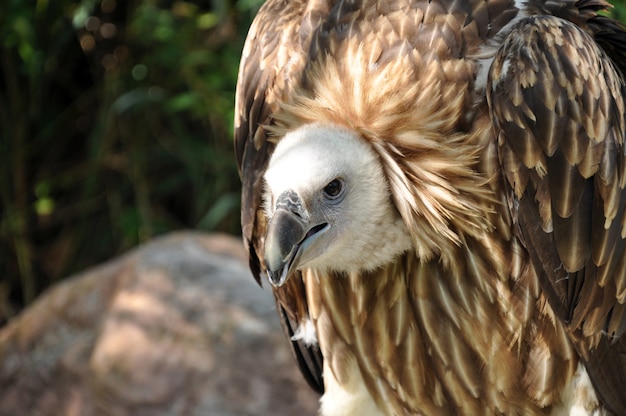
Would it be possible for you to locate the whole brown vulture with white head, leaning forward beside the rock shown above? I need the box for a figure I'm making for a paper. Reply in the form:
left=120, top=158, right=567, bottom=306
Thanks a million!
left=235, top=0, right=626, bottom=415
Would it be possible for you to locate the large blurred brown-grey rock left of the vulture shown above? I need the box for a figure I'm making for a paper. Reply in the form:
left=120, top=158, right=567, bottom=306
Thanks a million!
left=0, top=233, right=317, bottom=416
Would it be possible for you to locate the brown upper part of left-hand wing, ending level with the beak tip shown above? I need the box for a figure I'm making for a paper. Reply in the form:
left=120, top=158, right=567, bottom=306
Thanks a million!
left=235, top=1, right=305, bottom=283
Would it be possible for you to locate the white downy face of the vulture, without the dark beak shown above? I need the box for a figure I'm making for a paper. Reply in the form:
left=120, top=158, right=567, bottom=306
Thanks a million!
left=265, top=124, right=410, bottom=271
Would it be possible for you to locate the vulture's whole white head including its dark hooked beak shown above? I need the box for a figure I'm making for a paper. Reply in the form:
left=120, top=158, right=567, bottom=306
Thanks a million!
left=264, top=123, right=411, bottom=286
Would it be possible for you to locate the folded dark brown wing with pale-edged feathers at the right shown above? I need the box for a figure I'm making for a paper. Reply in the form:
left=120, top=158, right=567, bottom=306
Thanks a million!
left=487, top=8, right=626, bottom=414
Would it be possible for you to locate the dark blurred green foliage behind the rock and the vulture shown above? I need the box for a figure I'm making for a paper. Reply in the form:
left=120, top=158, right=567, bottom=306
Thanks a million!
left=0, top=0, right=626, bottom=325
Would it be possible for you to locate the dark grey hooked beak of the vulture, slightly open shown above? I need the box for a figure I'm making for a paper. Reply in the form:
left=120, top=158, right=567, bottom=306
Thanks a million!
left=264, top=191, right=328, bottom=287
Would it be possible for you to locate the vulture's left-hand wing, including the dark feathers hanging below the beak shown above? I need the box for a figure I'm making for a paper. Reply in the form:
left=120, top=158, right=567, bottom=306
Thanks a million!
left=230, top=0, right=328, bottom=392
